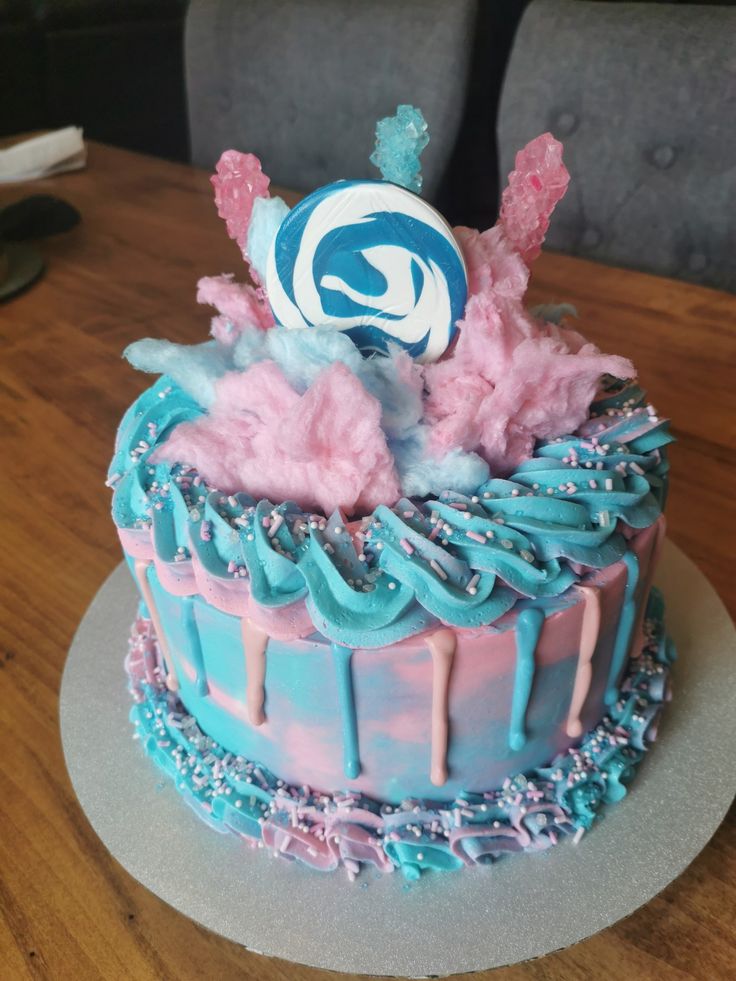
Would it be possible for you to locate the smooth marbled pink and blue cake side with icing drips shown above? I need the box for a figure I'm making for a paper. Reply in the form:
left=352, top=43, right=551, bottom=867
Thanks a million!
left=123, top=520, right=663, bottom=803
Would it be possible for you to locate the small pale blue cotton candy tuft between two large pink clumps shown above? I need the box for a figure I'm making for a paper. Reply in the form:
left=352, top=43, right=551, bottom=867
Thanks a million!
left=389, top=423, right=489, bottom=497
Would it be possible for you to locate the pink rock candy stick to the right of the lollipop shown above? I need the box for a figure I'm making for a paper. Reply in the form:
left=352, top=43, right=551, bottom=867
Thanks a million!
left=499, top=133, right=570, bottom=265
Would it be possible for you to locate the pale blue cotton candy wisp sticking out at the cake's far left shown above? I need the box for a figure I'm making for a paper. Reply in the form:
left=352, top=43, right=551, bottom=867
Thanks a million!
left=123, top=337, right=231, bottom=408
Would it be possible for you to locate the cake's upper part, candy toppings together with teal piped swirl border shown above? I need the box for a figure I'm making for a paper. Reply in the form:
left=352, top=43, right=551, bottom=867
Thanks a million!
left=109, top=107, right=671, bottom=646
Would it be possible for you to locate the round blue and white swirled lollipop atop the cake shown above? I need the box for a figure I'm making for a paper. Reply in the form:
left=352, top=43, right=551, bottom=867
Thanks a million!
left=266, top=180, right=468, bottom=362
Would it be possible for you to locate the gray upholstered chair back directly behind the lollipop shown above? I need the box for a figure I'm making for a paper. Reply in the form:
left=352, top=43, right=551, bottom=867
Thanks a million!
left=185, top=0, right=477, bottom=200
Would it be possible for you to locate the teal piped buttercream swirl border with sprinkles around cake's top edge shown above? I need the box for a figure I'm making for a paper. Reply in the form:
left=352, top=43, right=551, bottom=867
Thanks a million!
left=108, top=376, right=671, bottom=647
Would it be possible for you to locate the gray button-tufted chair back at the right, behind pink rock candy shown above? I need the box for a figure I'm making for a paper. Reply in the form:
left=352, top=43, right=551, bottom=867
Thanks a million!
left=498, top=0, right=736, bottom=291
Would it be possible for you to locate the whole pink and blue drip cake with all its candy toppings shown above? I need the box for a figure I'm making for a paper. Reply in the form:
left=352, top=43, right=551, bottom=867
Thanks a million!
left=108, top=106, right=674, bottom=879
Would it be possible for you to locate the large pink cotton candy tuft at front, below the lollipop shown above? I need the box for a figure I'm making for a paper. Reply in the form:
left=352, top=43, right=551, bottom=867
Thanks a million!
left=152, top=361, right=401, bottom=514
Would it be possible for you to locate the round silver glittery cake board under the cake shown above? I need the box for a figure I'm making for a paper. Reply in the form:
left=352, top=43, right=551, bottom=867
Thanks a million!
left=61, top=542, right=736, bottom=978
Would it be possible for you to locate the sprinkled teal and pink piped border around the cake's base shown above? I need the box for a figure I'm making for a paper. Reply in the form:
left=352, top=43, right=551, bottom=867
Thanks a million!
left=126, top=591, right=674, bottom=880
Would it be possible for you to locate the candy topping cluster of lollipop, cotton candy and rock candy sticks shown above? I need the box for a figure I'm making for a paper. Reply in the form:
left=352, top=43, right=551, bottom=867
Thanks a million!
left=121, top=106, right=634, bottom=515
